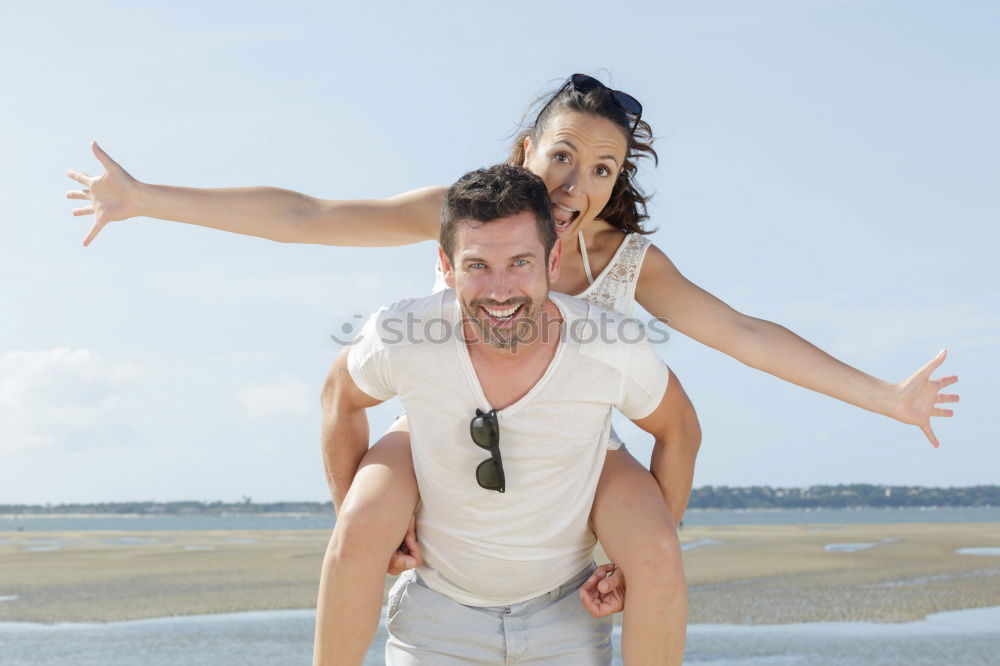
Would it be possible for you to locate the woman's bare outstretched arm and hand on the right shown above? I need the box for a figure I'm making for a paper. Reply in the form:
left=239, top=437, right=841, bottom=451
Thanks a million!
left=636, top=246, right=958, bottom=446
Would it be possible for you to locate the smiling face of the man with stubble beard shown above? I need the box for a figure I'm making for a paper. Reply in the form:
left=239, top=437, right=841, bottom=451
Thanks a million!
left=441, top=211, right=560, bottom=350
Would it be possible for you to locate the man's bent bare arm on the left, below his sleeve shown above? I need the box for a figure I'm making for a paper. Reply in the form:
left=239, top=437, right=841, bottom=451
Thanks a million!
left=320, top=347, right=382, bottom=513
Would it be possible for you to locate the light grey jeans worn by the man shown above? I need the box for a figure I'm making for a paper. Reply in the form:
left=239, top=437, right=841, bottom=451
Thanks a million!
left=385, top=564, right=611, bottom=666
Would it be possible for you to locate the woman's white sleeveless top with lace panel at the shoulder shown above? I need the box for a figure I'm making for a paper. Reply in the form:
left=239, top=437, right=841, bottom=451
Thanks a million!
left=432, top=232, right=651, bottom=317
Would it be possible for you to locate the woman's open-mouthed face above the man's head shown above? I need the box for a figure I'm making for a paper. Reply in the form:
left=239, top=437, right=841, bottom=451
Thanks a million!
left=524, top=111, right=628, bottom=237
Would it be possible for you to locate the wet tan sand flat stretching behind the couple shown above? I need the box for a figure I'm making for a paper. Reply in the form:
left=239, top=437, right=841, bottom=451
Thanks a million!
left=0, top=523, right=1000, bottom=624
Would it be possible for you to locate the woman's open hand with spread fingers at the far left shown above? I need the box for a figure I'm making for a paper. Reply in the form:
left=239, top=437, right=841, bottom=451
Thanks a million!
left=66, top=141, right=139, bottom=247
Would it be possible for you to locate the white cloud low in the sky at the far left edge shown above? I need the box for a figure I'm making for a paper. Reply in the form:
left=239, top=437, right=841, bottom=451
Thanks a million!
left=0, top=348, right=143, bottom=452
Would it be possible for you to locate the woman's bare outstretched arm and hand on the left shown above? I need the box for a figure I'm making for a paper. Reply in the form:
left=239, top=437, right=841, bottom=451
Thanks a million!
left=66, top=142, right=446, bottom=247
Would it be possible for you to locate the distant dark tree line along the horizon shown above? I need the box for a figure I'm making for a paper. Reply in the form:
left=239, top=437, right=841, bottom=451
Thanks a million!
left=0, top=483, right=1000, bottom=516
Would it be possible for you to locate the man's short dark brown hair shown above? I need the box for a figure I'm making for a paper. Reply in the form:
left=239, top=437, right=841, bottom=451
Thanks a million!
left=440, top=164, right=556, bottom=262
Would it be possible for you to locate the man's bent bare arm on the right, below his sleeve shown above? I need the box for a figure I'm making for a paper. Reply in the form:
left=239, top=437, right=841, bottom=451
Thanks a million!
left=633, top=370, right=701, bottom=525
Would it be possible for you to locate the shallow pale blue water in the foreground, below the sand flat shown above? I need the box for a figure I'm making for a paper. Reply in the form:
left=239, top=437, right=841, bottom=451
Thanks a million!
left=0, top=606, right=1000, bottom=666
